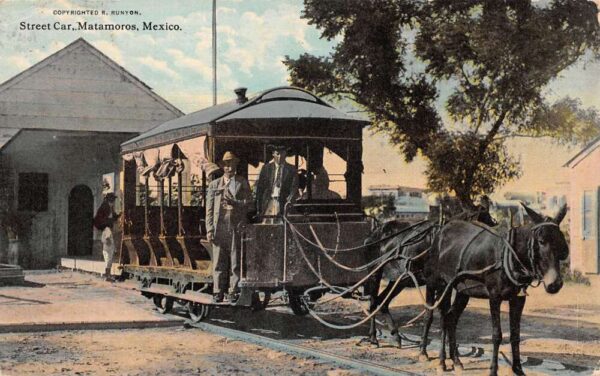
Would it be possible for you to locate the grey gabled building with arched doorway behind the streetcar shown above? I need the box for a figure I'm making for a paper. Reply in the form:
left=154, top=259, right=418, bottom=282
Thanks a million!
left=0, top=39, right=183, bottom=268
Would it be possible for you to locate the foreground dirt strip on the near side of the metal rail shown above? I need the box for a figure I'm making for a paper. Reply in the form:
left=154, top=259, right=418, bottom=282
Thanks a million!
left=0, top=328, right=348, bottom=376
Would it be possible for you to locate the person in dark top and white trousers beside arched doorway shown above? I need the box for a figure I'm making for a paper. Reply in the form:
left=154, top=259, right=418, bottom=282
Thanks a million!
left=94, top=193, right=120, bottom=282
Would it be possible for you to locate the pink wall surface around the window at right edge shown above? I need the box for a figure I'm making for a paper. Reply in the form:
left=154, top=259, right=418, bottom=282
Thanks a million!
left=569, top=148, right=600, bottom=274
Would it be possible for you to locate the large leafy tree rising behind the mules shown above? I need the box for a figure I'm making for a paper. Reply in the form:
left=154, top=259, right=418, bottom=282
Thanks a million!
left=284, top=0, right=600, bottom=205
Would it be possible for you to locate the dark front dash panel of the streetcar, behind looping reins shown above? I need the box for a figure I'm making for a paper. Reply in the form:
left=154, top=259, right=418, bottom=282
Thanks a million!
left=241, top=221, right=371, bottom=287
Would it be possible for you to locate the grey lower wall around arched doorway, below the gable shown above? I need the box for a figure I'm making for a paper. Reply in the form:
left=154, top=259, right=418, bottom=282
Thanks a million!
left=2, top=130, right=132, bottom=268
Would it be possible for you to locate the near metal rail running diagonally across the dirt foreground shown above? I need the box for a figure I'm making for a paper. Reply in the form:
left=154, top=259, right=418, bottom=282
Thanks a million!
left=187, top=322, right=418, bottom=376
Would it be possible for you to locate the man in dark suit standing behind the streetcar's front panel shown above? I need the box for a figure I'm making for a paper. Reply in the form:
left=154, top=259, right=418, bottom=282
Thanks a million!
left=256, top=146, right=298, bottom=223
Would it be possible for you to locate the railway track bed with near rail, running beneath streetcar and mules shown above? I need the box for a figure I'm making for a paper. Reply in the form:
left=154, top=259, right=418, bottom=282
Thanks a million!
left=176, top=307, right=593, bottom=376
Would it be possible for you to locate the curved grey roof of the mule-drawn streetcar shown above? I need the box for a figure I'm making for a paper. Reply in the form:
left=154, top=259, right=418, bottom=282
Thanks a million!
left=121, top=86, right=369, bottom=153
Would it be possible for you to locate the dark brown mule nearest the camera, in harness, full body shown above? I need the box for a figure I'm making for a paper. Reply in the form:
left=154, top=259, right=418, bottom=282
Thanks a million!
left=422, top=204, right=569, bottom=375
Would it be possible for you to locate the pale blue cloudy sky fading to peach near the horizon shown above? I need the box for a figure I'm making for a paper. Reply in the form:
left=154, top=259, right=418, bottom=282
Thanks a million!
left=0, top=0, right=600, bottom=196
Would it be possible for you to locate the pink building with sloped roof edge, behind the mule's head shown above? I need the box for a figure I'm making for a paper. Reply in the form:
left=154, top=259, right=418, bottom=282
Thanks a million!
left=565, top=137, right=600, bottom=274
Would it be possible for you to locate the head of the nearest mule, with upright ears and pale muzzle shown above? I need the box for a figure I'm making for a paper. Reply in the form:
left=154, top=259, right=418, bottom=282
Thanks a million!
left=521, top=203, right=569, bottom=294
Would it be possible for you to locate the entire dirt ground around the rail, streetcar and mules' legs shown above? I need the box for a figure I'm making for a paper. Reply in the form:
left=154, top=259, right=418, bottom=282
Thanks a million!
left=0, top=273, right=600, bottom=376
